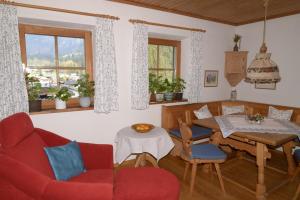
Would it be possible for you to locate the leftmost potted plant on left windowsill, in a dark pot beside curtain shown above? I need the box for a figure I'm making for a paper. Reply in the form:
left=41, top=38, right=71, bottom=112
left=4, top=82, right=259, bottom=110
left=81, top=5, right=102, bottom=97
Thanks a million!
left=25, top=73, right=42, bottom=112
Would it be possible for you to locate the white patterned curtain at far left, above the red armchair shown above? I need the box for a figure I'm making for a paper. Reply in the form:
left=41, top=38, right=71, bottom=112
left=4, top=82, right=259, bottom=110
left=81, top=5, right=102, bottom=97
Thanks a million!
left=0, top=4, right=28, bottom=120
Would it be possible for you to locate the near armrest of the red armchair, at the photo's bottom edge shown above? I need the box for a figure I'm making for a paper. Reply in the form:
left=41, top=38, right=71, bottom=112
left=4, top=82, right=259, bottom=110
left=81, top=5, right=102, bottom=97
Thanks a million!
left=42, top=180, right=113, bottom=200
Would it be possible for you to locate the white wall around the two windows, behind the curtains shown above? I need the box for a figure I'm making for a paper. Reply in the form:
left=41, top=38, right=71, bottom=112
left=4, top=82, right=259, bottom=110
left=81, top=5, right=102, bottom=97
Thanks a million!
left=14, top=0, right=235, bottom=144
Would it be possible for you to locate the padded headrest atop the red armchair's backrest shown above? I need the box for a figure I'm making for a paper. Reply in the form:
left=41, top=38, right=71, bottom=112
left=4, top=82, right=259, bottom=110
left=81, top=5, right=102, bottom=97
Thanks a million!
left=0, top=113, right=34, bottom=148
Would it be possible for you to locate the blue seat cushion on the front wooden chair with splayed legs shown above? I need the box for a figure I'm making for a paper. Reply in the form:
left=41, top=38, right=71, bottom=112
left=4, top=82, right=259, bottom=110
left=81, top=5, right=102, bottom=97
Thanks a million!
left=192, top=144, right=227, bottom=160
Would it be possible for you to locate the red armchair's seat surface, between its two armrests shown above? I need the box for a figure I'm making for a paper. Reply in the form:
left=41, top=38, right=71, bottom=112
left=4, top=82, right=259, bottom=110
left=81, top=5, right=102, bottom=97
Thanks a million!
left=69, top=169, right=114, bottom=185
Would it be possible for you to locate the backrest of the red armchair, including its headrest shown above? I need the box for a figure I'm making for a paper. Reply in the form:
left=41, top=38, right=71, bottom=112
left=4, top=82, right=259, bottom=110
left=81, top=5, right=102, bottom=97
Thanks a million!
left=0, top=113, right=54, bottom=178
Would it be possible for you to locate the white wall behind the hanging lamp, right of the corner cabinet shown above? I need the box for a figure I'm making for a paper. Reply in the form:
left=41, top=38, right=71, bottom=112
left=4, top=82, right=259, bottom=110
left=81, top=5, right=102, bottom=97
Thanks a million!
left=236, top=14, right=300, bottom=107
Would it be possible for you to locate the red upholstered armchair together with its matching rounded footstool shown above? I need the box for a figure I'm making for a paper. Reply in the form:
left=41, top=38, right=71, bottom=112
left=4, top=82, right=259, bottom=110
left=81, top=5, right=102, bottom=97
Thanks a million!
left=0, top=113, right=180, bottom=200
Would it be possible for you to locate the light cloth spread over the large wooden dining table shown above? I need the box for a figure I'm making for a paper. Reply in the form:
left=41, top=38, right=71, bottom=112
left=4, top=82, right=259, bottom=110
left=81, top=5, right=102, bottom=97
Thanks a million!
left=215, top=115, right=300, bottom=138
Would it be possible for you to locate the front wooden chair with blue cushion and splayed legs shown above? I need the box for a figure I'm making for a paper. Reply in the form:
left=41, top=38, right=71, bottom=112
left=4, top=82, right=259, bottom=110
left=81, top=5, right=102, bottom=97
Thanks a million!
left=178, top=119, right=227, bottom=194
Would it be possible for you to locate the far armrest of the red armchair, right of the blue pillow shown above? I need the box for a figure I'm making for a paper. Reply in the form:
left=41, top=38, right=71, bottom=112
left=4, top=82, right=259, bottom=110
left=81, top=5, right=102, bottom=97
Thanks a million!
left=79, top=143, right=113, bottom=170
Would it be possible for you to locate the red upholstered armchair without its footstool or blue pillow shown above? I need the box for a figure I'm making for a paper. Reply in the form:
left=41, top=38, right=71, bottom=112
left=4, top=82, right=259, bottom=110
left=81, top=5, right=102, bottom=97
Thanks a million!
left=0, top=113, right=113, bottom=200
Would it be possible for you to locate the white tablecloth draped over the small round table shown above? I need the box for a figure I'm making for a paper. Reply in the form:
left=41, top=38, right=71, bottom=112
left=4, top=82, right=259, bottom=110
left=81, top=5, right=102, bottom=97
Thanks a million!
left=115, top=127, right=174, bottom=163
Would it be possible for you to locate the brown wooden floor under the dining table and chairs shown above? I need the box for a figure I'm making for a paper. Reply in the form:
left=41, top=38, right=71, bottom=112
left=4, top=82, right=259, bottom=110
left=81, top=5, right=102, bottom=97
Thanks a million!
left=117, top=151, right=300, bottom=200
